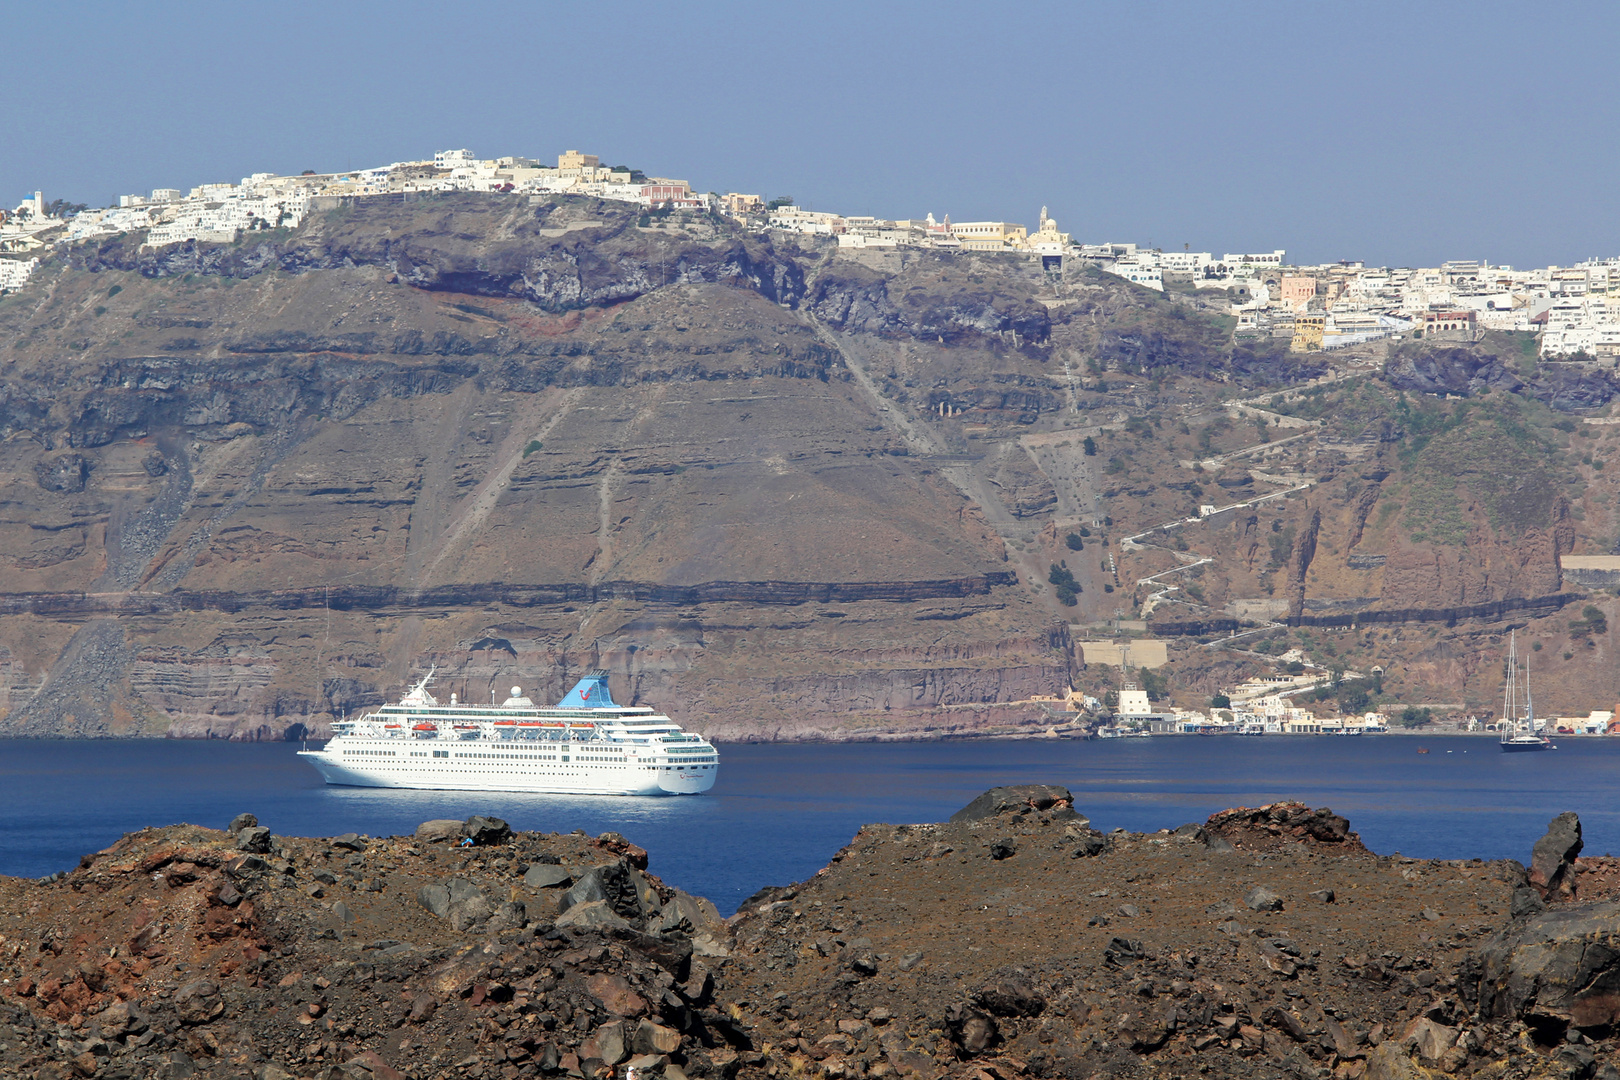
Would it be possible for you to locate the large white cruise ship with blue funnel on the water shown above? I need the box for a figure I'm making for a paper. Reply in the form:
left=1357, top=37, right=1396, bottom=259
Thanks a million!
left=298, top=670, right=719, bottom=795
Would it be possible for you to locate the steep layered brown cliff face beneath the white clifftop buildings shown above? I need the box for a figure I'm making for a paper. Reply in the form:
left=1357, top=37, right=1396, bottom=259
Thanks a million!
left=0, top=196, right=1612, bottom=738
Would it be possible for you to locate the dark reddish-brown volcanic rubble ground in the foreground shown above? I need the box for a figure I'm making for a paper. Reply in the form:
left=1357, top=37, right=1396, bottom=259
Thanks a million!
left=0, top=787, right=1620, bottom=1080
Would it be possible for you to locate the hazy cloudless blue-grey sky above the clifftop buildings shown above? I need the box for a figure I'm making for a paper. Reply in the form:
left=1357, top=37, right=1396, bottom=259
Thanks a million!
left=0, top=0, right=1620, bottom=266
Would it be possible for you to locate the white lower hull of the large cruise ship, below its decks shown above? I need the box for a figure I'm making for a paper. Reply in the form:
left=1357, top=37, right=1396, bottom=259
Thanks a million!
left=298, top=743, right=719, bottom=795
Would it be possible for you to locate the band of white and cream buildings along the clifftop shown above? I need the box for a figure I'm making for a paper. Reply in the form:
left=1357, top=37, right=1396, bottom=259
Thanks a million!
left=12, top=149, right=1620, bottom=361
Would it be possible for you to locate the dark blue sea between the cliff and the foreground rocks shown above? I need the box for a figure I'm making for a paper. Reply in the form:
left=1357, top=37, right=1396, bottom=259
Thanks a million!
left=0, top=735, right=1620, bottom=915
